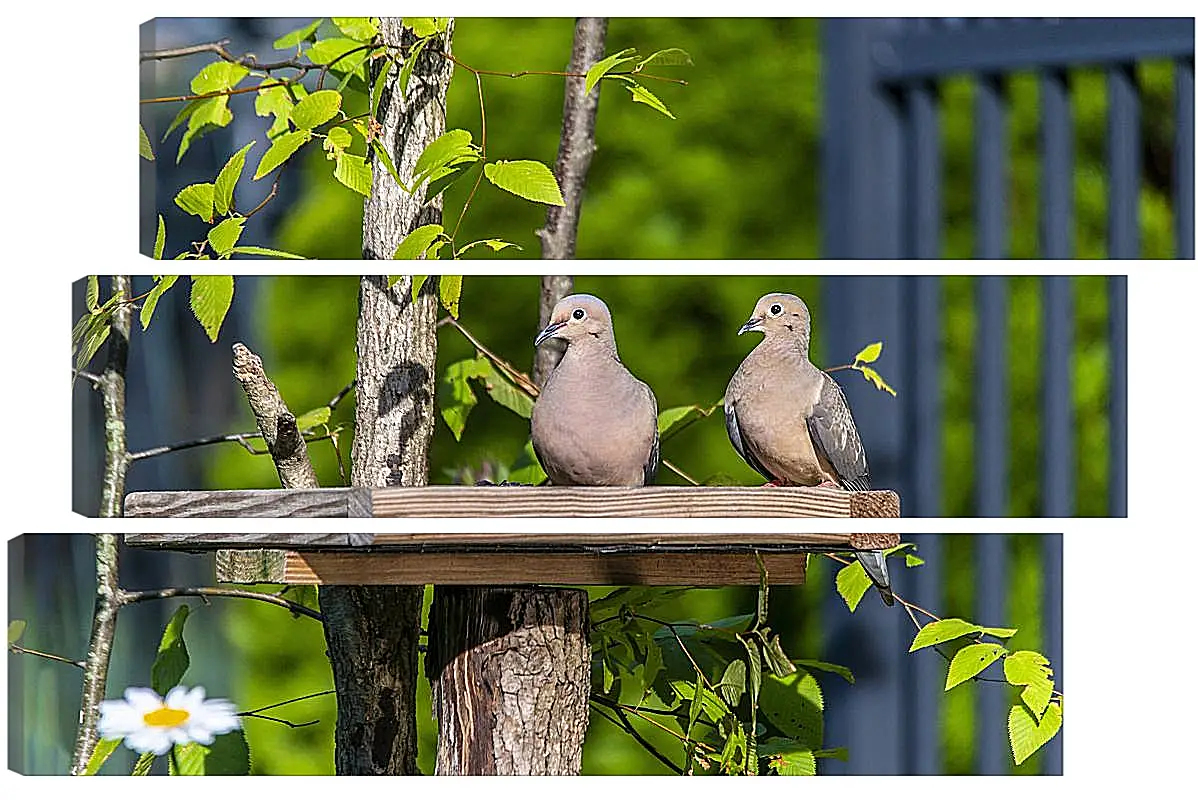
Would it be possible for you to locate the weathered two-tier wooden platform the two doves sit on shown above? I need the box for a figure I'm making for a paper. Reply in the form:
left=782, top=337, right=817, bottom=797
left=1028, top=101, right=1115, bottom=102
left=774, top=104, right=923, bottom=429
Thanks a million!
left=125, top=486, right=900, bottom=586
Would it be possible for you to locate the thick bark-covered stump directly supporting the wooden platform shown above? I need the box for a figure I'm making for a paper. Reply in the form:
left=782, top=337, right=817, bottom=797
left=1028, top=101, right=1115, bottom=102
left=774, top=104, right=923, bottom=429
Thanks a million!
left=426, top=587, right=591, bottom=775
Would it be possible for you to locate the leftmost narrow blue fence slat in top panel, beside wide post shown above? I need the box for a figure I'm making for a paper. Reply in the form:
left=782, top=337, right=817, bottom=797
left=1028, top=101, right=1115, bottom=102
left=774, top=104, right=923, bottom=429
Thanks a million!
left=903, top=81, right=940, bottom=259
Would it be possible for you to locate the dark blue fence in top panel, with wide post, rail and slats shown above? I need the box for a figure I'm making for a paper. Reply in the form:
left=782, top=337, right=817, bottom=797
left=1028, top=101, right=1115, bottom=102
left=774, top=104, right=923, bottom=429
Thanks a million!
left=821, top=18, right=1194, bottom=259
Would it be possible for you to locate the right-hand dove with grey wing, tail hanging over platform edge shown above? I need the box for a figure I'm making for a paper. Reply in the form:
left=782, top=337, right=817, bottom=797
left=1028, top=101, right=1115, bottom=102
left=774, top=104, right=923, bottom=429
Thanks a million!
left=724, top=293, right=894, bottom=606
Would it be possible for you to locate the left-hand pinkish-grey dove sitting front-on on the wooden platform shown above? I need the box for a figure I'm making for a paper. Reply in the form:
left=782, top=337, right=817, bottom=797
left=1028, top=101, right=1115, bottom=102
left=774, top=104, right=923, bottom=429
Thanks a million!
left=532, top=295, right=660, bottom=486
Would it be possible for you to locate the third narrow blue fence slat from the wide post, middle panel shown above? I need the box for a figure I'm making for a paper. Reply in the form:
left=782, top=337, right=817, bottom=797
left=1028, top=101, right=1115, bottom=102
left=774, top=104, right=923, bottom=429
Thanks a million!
left=1040, top=275, right=1077, bottom=516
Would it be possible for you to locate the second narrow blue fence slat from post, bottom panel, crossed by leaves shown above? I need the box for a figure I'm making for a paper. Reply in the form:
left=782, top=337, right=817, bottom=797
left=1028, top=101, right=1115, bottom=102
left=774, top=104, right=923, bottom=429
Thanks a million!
left=973, top=533, right=1011, bottom=775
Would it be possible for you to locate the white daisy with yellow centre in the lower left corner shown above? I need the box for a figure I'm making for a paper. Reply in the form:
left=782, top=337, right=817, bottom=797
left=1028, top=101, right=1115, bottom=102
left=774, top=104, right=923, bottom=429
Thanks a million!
left=98, top=686, right=241, bottom=756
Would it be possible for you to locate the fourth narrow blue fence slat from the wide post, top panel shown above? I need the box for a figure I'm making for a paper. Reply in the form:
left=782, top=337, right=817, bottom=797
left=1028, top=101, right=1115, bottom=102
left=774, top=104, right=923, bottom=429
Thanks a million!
left=1107, top=63, right=1140, bottom=259
